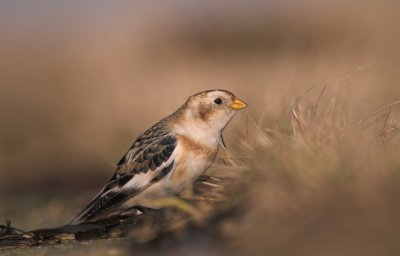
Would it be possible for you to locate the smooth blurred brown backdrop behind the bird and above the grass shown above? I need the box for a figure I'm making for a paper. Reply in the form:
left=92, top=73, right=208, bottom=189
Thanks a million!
left=0, top=0, right=400, bottom=255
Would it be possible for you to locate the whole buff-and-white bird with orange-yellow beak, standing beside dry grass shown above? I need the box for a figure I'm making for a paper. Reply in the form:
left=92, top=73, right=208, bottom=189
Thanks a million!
left=70, top=89, right=247, bottom=224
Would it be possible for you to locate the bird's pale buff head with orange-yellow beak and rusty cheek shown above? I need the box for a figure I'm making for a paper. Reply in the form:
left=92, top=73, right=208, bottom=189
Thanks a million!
left=175, top=90, right=247, bottom=139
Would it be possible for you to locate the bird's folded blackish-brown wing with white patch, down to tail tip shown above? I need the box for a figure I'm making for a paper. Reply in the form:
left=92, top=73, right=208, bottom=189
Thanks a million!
left=71, top=121, right=177, bottom=224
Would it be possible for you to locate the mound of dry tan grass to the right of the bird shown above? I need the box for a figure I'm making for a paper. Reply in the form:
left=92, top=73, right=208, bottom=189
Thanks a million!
left=222, top=87, right=400, bottom=255
